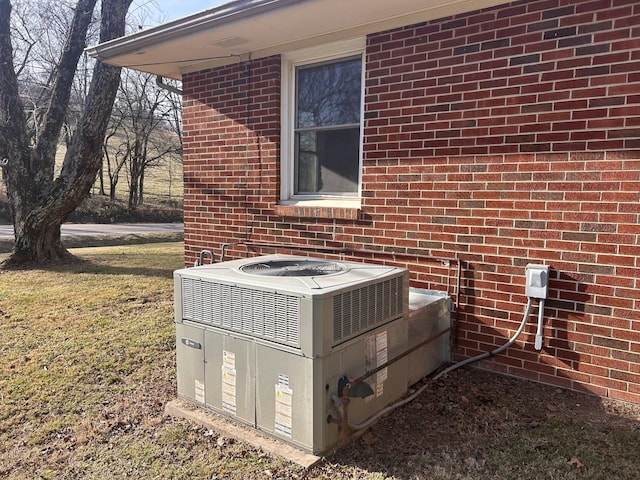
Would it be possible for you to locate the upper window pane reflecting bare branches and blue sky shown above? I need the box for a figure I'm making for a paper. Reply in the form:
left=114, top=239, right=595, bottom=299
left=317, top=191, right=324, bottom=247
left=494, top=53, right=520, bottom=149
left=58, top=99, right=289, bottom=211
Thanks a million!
left=296, top=57, right=362, bottom=128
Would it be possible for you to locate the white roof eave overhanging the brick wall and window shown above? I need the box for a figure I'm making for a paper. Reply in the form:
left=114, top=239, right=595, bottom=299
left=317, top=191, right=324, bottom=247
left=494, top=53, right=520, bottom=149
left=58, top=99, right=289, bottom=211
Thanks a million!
left=87, top=0, right=506, bottom=80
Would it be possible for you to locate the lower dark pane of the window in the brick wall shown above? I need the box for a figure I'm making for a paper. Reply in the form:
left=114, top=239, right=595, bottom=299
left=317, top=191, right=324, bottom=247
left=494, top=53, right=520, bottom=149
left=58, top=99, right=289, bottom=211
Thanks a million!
left=295, top=128, right=360, bottom=194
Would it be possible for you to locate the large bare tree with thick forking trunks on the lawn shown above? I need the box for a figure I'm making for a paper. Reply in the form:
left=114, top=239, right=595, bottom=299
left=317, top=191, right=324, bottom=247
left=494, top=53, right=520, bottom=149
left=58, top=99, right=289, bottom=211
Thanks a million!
left=0, top=0, right=131, bottom=265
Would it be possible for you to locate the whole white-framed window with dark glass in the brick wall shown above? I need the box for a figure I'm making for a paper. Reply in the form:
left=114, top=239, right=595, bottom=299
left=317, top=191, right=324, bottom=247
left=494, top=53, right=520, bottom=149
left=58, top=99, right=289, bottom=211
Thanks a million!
left=281, top=40, right=364, bottom=203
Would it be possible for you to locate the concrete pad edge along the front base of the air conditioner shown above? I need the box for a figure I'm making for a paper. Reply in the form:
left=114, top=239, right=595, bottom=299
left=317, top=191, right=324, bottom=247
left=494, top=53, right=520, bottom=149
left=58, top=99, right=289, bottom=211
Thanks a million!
left=164, top=398, right=321, bottom=468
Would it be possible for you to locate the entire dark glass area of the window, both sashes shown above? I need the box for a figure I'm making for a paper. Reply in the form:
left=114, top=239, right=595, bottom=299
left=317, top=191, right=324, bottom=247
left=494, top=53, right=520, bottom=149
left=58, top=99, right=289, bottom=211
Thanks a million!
left=295, top=57, right=362, bottom=195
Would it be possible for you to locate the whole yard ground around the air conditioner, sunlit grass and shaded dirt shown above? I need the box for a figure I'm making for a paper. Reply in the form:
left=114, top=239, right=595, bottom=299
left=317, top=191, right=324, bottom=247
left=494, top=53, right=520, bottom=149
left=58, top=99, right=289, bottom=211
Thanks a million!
left=0, top=243, right=640, bottom=480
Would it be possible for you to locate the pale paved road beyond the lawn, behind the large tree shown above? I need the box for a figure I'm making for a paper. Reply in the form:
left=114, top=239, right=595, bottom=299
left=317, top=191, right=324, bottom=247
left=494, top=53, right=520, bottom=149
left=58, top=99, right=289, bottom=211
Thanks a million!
left=0, top=223, right=184, bottom=240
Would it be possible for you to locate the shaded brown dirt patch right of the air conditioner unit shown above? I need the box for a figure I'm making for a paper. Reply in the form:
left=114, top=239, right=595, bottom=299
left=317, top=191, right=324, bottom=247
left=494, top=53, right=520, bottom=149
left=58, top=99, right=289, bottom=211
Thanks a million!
left=309, top=368, right=640, bottom=479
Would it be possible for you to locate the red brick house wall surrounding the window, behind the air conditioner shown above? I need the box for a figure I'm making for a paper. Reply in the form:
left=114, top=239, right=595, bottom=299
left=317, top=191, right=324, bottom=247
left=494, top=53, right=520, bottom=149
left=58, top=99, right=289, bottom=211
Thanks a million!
left=183, top=0, right=640, bottom=402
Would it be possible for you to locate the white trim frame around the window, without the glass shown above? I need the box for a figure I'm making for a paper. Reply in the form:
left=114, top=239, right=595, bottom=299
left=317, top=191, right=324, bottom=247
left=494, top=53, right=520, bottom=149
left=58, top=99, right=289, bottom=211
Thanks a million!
left=280, top=37, right=366, bottom=208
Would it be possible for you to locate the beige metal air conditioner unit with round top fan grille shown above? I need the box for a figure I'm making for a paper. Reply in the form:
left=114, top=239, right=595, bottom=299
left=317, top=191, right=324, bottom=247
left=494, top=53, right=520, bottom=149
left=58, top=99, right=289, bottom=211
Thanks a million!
left=174, top=255, right=448, bottom=454
